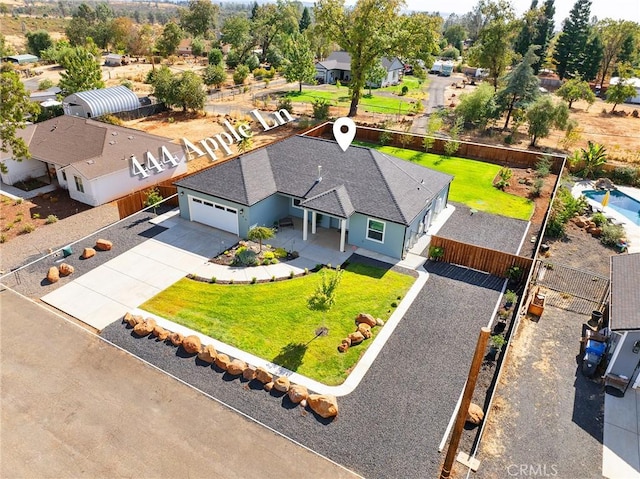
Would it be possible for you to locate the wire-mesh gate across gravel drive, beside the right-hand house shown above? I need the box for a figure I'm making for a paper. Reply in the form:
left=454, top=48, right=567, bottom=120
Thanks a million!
left=532, top=260, right=609, bottom=314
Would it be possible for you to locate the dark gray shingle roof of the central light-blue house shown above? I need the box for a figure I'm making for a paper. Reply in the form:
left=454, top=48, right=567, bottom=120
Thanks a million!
left=176, top=136, right=453, bottom=225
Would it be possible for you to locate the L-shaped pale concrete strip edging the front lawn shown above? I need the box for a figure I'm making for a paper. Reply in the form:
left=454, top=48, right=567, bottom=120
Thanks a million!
left=136, top=268, right=429, bottom=397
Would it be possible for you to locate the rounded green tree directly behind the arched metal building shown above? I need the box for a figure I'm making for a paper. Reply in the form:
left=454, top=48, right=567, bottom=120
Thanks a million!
left=58, top=47, right=104, bottom=96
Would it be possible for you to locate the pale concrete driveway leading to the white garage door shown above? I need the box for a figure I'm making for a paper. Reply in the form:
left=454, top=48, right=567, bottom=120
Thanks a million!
left=41, top=216, right=238, bottom=331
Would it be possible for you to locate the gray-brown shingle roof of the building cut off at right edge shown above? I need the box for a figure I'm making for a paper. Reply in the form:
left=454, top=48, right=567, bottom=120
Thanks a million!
left=609, top=253, right=640, bottom=330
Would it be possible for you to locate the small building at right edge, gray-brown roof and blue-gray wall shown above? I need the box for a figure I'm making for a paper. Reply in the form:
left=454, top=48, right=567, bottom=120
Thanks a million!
left=604, top=253, right=640, bottom=392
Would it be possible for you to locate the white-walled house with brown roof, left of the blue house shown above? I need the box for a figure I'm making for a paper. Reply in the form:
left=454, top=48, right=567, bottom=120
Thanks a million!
left=0, top=115, right=187, bottom=206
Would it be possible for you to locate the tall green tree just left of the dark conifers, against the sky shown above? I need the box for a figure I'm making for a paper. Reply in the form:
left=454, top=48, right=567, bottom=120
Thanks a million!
left=471, top=0, right=517, bottom=91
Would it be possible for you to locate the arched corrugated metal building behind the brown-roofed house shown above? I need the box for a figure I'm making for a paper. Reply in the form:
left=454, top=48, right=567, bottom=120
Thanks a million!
left=62, top=85, right=140, bottom=118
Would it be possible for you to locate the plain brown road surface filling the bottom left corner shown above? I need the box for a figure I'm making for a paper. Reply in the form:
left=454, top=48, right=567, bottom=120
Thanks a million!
left=0, top=289, right=355, bottom=479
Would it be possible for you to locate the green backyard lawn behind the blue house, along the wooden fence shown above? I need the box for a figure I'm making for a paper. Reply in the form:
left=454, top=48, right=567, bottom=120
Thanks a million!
left=376, top=144, right=534, bottom=220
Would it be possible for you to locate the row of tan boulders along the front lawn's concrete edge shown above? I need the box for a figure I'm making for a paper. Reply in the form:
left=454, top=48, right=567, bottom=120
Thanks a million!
left=122, top=312, right=340, bottom=419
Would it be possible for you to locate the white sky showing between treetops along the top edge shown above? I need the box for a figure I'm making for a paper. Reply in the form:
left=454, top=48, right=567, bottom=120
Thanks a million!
left=346, top=0, right=640, bottom=24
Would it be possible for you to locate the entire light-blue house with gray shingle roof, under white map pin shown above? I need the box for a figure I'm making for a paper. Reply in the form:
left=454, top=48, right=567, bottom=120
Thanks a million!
left=176, top=136, right=453, bottom=258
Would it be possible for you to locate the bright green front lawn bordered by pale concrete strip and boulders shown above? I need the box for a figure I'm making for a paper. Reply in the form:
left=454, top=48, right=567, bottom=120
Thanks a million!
left=141, top=263, right=414, bottom=385
